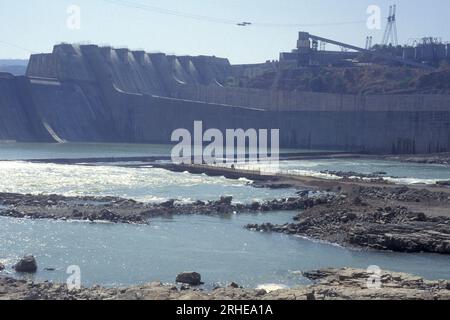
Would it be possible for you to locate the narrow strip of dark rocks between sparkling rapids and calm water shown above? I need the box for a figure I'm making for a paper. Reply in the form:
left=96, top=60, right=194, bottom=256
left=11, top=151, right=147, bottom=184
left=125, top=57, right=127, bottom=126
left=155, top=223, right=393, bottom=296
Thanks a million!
left=0, top=192, right=334, bottom=223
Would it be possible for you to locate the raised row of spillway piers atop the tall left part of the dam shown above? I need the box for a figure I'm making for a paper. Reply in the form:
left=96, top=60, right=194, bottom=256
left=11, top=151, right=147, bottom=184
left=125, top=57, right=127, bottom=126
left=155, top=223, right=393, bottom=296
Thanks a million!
left=27, top=44, right=232, bottom=96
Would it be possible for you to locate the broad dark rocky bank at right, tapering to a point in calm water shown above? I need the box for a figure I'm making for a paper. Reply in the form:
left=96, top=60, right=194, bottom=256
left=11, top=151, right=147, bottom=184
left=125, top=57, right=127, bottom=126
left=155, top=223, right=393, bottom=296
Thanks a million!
left=246, top=186, right=450, bottom=254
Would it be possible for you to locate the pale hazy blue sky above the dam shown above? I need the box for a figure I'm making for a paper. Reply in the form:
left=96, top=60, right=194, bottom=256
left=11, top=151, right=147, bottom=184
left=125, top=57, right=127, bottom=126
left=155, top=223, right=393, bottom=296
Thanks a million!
left=0, top=0, right=450, bottom=64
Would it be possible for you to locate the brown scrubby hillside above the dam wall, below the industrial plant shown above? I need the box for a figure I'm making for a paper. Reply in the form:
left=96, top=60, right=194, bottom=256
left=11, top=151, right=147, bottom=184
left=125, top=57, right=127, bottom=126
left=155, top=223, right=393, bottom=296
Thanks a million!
left=236, top=65, right=450, bottom=94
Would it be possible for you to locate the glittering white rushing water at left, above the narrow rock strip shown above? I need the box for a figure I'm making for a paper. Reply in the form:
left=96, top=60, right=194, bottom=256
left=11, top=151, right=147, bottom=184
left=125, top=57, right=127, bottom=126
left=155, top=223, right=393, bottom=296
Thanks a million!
left=0, top=161, right=294, bottom=202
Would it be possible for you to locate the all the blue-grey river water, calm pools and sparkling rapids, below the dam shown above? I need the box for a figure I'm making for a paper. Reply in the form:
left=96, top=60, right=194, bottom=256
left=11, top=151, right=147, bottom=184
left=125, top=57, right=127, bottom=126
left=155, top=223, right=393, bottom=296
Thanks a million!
left=0, top=144, right=450, bottom=287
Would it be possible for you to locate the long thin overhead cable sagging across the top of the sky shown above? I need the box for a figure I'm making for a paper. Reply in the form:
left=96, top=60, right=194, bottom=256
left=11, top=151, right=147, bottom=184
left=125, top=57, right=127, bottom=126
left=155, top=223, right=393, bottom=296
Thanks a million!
left=103, top=0, right=367, bottom=28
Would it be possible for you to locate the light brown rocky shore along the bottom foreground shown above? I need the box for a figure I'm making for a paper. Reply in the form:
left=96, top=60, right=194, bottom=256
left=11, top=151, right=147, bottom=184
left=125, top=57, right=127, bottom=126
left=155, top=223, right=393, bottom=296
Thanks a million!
left=0, top=268, right=450, bottom=300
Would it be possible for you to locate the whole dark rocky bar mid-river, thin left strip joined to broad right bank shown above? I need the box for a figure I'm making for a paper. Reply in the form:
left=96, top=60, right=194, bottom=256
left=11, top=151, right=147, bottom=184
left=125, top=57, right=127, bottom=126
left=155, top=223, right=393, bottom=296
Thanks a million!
left=0, top=165, right=450, bottom=254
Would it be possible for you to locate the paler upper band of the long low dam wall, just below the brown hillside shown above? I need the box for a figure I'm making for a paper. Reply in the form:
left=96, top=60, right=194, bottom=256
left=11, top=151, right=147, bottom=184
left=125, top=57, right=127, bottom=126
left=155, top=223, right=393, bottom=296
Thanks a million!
left=171, top=84, right=450, bottom=112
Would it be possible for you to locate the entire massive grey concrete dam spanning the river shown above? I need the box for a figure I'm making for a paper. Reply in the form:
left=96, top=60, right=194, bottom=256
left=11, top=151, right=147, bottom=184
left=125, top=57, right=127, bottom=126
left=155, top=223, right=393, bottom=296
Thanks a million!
left=0, top=44, right=450, bottom=153
